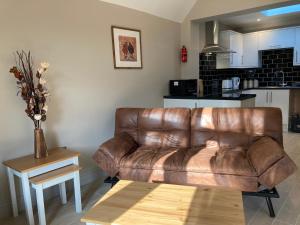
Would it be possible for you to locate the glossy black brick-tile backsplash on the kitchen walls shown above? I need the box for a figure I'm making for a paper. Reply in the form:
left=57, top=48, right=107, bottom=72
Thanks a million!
left=199, top=48, right=300, bottom=94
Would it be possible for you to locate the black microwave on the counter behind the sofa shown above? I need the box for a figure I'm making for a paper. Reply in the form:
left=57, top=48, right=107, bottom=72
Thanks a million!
left=169, top=79, right=200, bottom=96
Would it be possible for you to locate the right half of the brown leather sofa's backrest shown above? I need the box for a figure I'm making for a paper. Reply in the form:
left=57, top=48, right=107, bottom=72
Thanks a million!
left=191, top=108, right=282, bottom=148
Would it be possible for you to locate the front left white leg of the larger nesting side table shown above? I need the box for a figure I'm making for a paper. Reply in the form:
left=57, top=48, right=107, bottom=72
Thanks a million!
left=21, top=173, right=34, bottom=225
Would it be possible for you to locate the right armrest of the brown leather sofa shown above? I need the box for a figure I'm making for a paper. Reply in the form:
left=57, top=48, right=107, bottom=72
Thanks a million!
left=247, top=137, right=297, bottom=188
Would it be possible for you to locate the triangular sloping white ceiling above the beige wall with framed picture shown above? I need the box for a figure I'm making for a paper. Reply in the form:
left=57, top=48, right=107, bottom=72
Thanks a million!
left=101, top=0, right=197, bottom=23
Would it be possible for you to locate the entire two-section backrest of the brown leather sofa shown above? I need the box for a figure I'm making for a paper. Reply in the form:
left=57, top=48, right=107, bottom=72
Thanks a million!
left=115, top=108, right=282, bottom=148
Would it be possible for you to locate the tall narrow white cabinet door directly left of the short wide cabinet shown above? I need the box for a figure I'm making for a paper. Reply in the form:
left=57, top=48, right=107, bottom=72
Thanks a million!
left=242, top=32, right=259, bottom=68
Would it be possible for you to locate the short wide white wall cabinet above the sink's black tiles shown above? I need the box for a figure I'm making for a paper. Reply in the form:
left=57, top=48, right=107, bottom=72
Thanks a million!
left=258, top=27, right=296, bottom=50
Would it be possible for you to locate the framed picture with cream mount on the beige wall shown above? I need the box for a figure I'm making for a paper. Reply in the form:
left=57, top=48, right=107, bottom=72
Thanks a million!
left=111, top=26, right=143, bottom=69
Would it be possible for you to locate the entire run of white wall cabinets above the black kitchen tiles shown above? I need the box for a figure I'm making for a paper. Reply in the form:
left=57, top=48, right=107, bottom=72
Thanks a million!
left=217, top=27, right=300, bottom=69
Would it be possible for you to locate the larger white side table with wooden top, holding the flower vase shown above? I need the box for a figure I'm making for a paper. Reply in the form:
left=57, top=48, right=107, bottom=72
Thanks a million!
left=3, top=148, right=80, bottom=225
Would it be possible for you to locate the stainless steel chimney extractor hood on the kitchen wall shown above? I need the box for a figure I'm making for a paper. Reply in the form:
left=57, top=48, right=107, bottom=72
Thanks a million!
left=201, top=20, right=235, bottom=54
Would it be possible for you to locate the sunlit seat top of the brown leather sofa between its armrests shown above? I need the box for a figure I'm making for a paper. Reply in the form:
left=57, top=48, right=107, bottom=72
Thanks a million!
left=120, top=146, right=257, bottom=176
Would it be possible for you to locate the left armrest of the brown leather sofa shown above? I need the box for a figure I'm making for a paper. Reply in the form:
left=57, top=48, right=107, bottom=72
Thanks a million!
left=93, top=133, right=138, bottom=176
